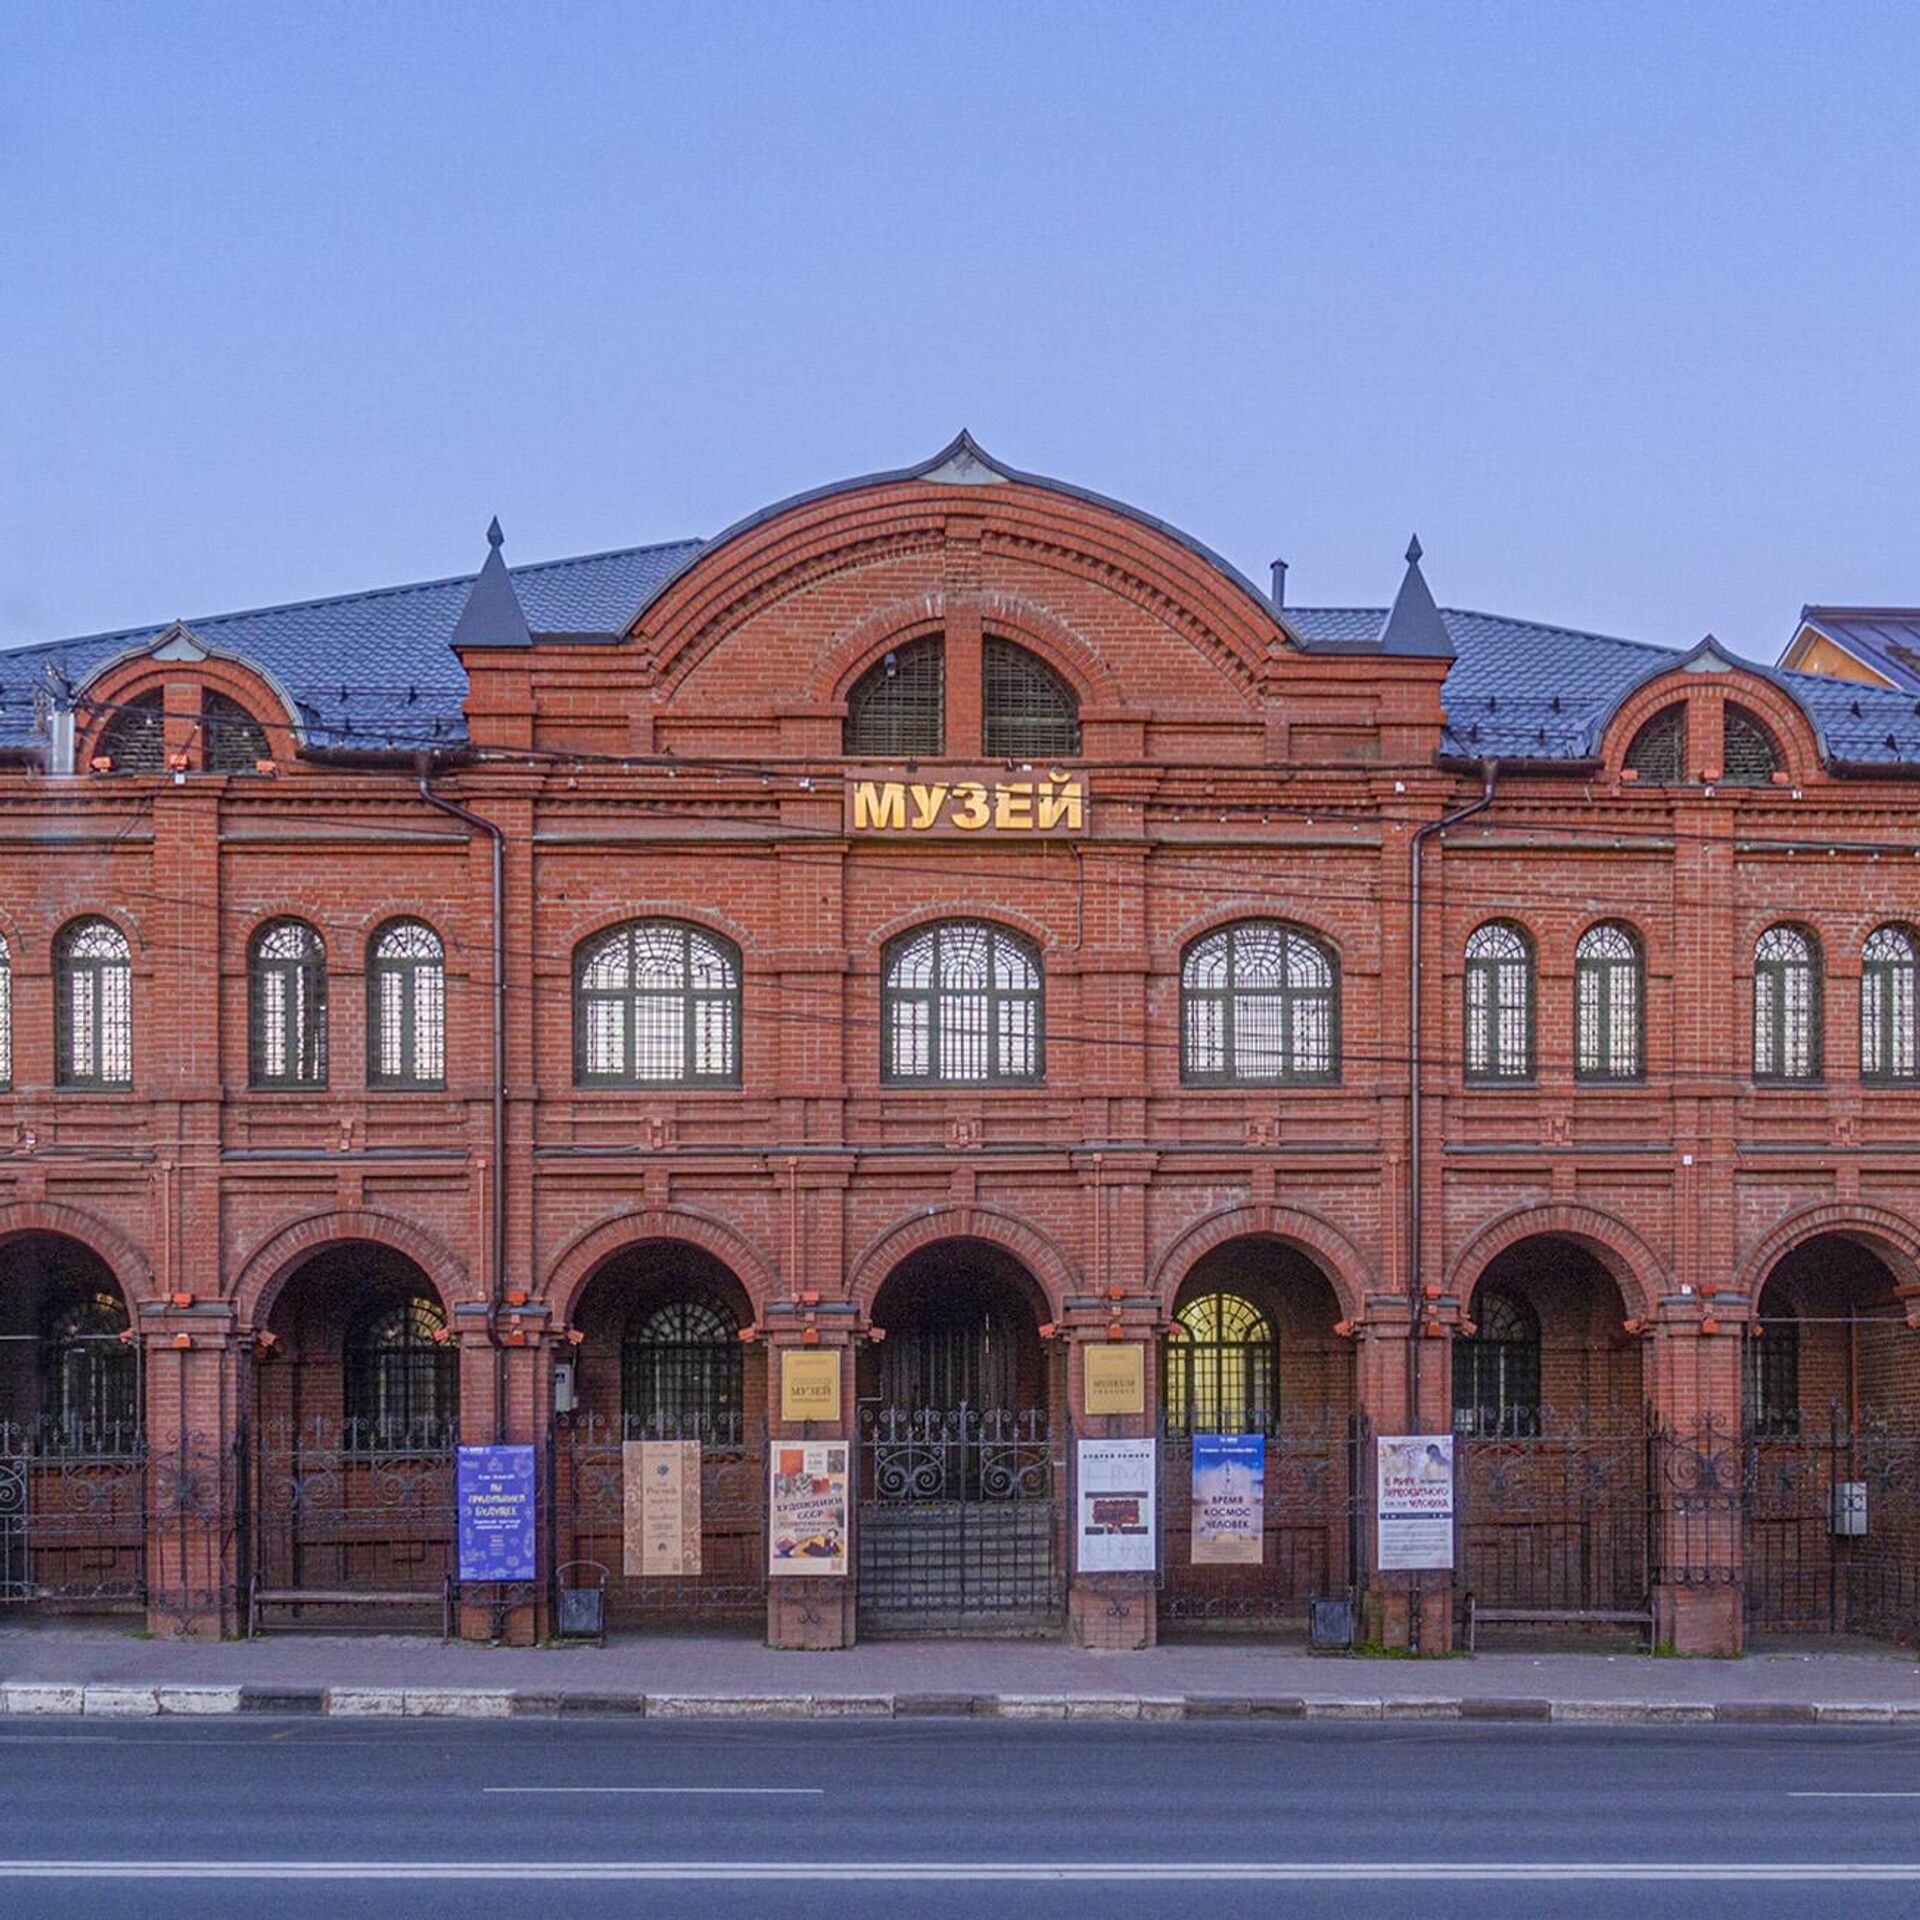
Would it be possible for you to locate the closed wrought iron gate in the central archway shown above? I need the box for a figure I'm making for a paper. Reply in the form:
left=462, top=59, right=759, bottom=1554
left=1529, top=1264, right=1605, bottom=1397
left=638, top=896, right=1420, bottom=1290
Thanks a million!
left=858, top=1404, right=1066, bottom=1634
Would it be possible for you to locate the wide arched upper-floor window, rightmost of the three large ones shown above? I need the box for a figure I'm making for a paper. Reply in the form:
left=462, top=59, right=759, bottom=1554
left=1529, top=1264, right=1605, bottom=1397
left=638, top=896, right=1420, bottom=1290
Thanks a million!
left=1181, top=920, right=1340, bottom=1087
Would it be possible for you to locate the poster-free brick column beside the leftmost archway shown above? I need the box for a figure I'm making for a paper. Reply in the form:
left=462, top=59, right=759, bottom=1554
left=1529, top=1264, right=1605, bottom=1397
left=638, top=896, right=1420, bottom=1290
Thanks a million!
left=141, top=1292, right=248, bottom=1640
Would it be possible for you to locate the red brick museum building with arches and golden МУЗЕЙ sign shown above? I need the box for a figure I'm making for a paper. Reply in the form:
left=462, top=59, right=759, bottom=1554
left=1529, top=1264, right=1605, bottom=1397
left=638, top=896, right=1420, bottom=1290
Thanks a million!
left=0, top=438, right=1920, bottom=1649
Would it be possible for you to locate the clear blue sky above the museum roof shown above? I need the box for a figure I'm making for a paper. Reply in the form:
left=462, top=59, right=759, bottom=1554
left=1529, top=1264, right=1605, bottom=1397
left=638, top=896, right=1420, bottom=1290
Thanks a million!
left=0, top=0, right=1920, bottom=657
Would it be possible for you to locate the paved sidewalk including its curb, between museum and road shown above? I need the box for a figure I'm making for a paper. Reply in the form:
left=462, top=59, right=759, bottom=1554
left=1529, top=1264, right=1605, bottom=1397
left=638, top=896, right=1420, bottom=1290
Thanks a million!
left=0, top=1626, right=1920, bottom=1726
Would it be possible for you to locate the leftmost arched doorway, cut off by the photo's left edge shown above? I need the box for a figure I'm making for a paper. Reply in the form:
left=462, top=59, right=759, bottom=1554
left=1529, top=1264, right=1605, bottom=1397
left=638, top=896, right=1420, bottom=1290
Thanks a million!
left=0, top=1233, right=146, bottom=1611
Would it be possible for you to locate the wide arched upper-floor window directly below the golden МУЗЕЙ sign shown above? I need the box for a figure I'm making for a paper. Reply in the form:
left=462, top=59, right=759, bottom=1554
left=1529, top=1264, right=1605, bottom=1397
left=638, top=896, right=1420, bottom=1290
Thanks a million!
left=879, top=920, right=1043, bottom=1087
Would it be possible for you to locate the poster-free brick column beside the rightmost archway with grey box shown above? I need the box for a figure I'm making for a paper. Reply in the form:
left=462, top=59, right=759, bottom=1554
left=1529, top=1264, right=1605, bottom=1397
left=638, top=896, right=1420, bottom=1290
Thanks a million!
left=1628, top=1283, right=1751, bottom=1653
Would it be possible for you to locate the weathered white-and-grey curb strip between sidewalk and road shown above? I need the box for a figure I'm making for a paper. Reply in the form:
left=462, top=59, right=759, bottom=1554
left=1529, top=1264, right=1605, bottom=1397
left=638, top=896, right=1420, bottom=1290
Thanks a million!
left=11, top=1680, right=1920, bottom=1726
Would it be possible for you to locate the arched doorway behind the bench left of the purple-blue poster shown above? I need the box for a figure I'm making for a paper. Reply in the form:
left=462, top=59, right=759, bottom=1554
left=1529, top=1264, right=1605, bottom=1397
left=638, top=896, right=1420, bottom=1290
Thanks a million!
left=244, top=1240, right=461, bottom=1624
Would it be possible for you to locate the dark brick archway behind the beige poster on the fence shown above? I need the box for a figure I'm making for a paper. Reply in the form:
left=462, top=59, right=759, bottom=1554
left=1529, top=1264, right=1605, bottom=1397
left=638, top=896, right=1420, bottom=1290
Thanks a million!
left=553, top=1240, right=766, bottom=1630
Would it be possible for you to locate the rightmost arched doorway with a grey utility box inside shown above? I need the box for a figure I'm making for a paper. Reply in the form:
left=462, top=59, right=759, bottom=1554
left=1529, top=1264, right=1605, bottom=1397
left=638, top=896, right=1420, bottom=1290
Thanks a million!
left=1741, top=1233, right=1920, bottom=1638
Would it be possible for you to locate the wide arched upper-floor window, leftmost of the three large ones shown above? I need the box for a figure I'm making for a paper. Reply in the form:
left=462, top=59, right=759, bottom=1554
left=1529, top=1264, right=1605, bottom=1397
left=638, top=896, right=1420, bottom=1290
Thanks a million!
left=574, top=920, right=739, bottom=1087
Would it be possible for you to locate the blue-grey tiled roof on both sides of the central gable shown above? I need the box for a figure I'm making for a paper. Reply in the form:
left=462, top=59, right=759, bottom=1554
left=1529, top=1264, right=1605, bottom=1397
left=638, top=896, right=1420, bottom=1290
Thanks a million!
left=11, top=540, right=1920, bottom=766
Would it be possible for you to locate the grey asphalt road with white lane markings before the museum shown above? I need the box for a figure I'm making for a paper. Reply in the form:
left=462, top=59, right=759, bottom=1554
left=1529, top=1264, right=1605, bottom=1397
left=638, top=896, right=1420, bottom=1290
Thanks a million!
left=0, top=1718, right=1920, bottom=1920
